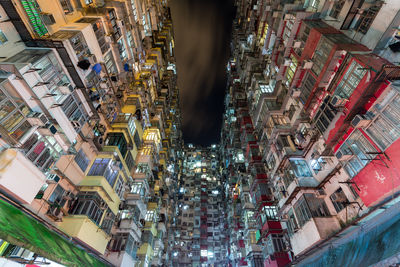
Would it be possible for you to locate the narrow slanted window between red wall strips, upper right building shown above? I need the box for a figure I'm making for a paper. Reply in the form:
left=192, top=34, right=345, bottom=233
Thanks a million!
left=335, top=60, right=367, bottom=99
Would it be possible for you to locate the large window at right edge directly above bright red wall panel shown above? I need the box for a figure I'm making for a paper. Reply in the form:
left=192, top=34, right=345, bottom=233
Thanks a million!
left=367, top=95, right=400, bottom=151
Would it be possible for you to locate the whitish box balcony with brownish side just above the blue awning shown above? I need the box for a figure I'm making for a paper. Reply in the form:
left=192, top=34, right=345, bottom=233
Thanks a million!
left=290, top=216, right=341, bottom=255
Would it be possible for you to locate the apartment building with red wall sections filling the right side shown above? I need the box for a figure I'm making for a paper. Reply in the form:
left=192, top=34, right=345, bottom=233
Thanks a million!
left=221, top=0, right=400, bottom=266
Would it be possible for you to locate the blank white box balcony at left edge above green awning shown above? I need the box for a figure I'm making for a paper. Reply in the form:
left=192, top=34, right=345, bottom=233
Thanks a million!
left=0, top=149, right=46, bottom=204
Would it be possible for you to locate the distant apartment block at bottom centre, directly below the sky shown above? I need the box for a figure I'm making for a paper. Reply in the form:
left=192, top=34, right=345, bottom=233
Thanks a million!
left=168, top=144, right=228, bottom=266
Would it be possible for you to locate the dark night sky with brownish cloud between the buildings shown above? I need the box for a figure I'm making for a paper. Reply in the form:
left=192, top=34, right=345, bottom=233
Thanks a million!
left=171, top=0, right=234, bottom=146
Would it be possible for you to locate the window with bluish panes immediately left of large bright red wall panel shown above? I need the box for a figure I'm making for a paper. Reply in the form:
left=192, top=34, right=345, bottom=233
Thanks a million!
left=339, top=130, right=376, bottom=177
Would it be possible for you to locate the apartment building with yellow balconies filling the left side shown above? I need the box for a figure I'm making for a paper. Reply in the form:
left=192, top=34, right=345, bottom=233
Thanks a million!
left=0, top=0, right=182, bottom=266
